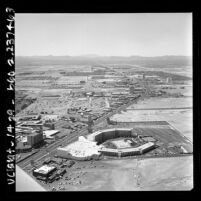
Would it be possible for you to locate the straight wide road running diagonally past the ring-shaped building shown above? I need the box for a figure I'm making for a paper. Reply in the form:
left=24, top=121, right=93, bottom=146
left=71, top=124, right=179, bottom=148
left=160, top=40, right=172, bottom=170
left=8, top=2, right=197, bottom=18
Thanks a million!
left=18, top=98, right=139, bottom=169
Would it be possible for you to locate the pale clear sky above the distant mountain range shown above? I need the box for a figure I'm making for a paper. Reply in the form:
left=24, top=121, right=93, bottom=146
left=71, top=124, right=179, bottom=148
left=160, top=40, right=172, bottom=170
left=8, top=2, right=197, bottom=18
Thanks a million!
left=15, top=13, right=192, bottom=56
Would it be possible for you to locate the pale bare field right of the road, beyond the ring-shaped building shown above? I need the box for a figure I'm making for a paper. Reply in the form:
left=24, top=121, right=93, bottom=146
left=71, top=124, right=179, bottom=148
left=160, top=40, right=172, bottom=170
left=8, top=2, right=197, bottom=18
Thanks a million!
left=111, top=97, right=193, bottom=141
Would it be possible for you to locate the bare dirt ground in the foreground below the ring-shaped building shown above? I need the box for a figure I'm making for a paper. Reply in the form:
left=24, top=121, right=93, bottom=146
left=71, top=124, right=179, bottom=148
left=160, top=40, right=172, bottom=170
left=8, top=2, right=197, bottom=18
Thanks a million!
left=46, top=156, right=193, bottom=191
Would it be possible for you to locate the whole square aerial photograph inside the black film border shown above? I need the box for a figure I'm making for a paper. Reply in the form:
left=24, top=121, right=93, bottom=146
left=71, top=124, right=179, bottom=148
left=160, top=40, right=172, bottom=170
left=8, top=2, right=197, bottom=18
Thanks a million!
left=15, top=13, right=194, bottom=192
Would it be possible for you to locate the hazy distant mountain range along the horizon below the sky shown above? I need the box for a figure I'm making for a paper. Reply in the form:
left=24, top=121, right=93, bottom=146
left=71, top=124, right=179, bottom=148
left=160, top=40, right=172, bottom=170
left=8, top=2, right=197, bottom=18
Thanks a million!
left=16, top=54, right=192, bottom=68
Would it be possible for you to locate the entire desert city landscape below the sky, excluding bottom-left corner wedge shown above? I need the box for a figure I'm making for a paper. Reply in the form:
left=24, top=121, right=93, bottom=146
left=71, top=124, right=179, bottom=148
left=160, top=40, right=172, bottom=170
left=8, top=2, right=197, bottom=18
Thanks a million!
left=15, top=57, right=193, bottom=191
